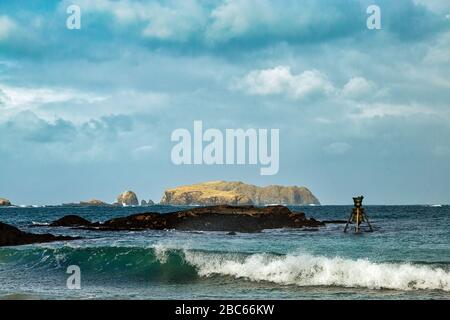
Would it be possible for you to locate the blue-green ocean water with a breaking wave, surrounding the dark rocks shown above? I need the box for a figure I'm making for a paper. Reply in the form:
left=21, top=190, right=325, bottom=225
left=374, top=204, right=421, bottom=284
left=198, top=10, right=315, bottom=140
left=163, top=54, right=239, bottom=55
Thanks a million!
left=0, top=206, right=450, bottom=299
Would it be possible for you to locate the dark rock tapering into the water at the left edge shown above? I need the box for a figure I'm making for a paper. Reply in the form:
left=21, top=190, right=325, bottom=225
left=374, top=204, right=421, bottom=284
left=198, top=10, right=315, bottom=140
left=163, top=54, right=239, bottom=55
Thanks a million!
left=0, top=222, right=80, bottom=247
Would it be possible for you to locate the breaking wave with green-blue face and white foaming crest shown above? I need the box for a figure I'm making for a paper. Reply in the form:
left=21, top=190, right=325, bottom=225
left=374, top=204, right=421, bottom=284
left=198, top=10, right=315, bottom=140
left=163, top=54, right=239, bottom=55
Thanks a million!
left=0, top=246, right=450, bottom=292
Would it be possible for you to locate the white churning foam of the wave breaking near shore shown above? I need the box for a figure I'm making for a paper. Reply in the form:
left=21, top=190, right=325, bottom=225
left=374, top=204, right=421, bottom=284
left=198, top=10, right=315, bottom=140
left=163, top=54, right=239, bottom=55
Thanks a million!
left=185, top=251, right=450, bottom=291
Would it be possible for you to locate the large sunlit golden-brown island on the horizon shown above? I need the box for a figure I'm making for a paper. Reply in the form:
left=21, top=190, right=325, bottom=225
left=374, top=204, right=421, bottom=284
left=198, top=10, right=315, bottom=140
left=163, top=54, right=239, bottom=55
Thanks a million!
left=160, top=181, right=320, bottom=205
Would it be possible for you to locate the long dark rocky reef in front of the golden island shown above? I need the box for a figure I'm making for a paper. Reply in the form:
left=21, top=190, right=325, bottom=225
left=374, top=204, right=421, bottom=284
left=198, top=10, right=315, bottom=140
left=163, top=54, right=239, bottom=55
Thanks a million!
left=51, top=205, right=324, bottom=232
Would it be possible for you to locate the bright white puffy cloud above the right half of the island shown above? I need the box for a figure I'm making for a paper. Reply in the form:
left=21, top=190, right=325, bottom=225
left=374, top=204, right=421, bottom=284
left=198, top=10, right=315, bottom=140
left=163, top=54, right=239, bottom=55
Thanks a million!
left=236, top=66, right=335, bottom=99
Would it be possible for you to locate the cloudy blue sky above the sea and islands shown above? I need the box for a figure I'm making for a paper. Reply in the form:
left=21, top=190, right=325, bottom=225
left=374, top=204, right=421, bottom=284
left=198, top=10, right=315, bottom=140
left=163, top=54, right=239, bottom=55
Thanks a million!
left=0, top=0, right=450, bottom=204
